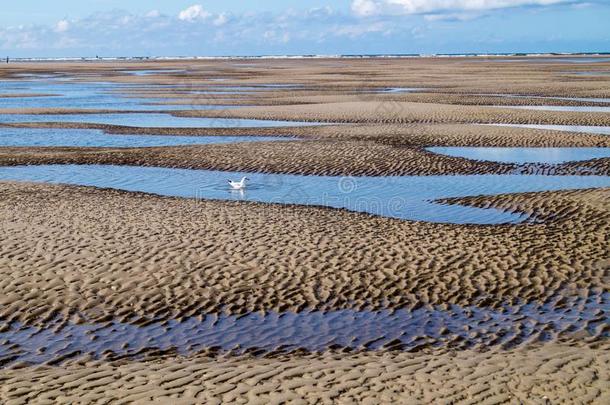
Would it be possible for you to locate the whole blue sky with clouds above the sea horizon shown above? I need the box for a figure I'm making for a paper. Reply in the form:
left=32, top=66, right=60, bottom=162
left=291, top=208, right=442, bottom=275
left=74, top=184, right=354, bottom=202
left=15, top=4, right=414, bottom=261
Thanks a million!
left=0, top=0, right=610, bottom=57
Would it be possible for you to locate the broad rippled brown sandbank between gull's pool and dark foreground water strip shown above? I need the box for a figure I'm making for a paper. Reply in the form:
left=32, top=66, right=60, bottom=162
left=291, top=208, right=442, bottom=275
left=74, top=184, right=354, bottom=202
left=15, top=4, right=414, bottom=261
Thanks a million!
left=0, top=183, right=610, bottom=325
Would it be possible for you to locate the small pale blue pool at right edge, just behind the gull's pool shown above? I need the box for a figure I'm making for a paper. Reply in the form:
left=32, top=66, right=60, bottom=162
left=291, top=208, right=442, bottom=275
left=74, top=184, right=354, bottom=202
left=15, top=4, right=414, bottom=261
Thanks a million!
left=426, top=146, right=610, bottom=164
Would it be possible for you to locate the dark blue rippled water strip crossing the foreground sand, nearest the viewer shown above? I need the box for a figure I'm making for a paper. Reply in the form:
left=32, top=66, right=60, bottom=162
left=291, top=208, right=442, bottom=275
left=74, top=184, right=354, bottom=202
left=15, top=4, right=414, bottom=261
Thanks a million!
left=0, top=293, right=610, bottom=364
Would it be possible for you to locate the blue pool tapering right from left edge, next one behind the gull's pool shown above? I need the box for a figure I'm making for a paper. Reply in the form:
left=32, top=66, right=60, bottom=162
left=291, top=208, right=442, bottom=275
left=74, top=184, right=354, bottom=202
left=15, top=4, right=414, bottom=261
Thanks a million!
left=0, top=128, right=291, bottom=148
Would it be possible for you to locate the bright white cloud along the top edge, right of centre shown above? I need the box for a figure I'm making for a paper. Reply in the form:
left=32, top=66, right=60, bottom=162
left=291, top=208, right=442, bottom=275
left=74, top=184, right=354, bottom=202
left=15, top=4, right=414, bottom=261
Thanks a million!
left=352, top=0, right=576, bottom=16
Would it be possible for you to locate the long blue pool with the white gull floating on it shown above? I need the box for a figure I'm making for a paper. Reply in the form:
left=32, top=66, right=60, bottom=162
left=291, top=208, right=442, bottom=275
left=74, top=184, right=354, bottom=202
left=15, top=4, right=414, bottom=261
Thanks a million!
left=0, top=165, right=610, bottom=224
